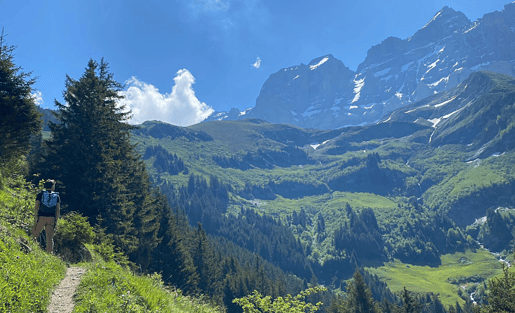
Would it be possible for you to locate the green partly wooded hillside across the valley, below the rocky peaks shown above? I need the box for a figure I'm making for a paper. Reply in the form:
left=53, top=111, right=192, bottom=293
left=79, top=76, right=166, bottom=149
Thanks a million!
left=133, top=72, right=515, bottom=303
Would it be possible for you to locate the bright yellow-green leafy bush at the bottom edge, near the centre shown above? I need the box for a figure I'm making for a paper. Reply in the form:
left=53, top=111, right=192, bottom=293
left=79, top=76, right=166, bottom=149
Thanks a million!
left=234, top=287, right=327, bottom=313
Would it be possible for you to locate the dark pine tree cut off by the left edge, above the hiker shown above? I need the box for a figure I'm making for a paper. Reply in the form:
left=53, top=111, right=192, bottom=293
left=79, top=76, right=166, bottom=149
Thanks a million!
left=0, top=29, right=41, bottom=166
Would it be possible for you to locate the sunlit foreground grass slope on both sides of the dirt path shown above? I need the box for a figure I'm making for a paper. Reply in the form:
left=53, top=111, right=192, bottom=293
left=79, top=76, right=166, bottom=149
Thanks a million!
left=0, top=162, right=222, bottom=313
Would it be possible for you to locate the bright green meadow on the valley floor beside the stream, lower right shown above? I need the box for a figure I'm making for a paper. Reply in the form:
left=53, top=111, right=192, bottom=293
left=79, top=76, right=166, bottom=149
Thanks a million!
left=367, top=249, right=502, bottom=306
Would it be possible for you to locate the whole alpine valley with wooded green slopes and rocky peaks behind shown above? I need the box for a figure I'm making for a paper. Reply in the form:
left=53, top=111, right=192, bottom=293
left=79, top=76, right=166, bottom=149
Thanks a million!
left=33, top=3, right=515, bottom=312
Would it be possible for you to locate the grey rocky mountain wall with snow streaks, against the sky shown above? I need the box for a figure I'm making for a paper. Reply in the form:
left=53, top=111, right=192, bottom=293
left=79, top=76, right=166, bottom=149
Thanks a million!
left=208, top=3, right=515, bottom=129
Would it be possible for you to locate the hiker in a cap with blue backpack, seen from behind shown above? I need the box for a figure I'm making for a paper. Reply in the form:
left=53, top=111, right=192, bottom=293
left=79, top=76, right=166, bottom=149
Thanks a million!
left=32, top=179, right=61, bottom=253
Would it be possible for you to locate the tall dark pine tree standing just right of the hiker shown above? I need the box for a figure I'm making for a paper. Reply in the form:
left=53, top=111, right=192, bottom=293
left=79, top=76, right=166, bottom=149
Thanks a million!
left=40, top=59, right=144, bottom=253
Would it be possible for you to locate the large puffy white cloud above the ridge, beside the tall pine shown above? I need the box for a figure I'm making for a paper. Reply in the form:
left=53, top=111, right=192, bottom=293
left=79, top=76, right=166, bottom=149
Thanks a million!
left=121, top=69, right=214, bottom=126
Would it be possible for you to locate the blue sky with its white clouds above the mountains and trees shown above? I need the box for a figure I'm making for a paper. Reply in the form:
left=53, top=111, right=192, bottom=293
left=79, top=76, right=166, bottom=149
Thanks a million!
left=0, top=0, right=509, bottom=126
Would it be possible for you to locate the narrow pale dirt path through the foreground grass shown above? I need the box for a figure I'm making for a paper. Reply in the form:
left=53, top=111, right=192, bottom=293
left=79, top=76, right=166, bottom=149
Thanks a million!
left=48, top=267, right=86, bottom=313
